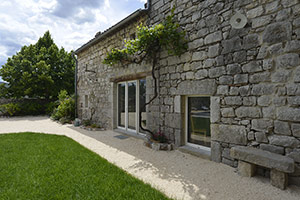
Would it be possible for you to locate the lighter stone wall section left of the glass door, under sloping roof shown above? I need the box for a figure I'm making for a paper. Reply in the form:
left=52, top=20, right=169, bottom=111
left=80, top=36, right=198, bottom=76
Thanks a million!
left=77, top=16, right=151, bottom=129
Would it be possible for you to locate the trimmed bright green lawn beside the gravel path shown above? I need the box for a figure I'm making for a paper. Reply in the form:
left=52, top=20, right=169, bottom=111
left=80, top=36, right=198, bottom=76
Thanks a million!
left=0, top=133, right=168, bottom=200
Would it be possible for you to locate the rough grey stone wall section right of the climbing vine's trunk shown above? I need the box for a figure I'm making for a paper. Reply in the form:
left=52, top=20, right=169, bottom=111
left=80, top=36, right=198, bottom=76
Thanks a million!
left=150, top=0, right=300, bottom=184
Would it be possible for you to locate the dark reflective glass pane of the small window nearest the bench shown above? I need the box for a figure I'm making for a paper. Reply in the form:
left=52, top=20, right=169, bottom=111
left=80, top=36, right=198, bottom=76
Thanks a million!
left=188, top=97, right=210, bottom=147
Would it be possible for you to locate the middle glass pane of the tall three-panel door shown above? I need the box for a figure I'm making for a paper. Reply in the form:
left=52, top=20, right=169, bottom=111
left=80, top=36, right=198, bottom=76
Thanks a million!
left=128, top=82, right=136, bottom=130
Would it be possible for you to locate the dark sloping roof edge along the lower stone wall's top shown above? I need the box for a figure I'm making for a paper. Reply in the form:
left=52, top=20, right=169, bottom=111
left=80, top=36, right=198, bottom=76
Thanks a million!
left=74, top=9, right=148, bottom=54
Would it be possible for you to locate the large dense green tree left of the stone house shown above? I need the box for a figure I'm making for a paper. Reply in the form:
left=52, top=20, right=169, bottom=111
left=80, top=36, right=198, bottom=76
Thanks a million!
left=0, top=31, right=75, bottom=100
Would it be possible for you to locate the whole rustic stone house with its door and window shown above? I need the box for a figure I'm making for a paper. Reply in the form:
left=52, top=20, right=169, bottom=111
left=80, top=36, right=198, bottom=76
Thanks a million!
left=76, top=0, right=300, bottom=188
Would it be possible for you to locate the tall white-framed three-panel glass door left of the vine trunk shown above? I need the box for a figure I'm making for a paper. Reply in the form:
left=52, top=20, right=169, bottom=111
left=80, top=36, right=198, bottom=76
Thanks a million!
left=118, top=79, right=146, bottom=133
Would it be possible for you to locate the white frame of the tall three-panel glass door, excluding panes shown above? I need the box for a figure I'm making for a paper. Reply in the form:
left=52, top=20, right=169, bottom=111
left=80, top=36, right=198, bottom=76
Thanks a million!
left=117, top=80, right=145, bottom=136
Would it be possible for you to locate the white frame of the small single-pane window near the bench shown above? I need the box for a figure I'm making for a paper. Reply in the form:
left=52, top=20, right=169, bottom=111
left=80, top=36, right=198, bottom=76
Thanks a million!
left=184, top=95, right=211, bottom=152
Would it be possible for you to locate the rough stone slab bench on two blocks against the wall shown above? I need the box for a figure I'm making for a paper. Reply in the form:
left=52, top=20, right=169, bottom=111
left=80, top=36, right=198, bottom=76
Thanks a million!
left=230, top=146, right=295, bottom=190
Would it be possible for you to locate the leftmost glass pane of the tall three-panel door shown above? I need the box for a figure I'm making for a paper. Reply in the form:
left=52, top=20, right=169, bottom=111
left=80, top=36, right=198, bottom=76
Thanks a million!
left=118, top=83, right=125, bottom=127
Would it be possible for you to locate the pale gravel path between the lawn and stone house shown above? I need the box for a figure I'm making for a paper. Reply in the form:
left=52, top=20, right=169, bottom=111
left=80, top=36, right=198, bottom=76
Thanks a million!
left=0, top=117, right=300, bottom=200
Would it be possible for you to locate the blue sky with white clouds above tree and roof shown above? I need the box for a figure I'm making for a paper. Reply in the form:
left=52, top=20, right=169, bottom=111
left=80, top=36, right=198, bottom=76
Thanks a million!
left=0, top=0, right=147, bottom=81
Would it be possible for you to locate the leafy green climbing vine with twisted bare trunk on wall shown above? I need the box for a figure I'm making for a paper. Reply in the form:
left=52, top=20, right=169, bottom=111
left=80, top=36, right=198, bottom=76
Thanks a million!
left=103, top=7, right=187, bottom=139
